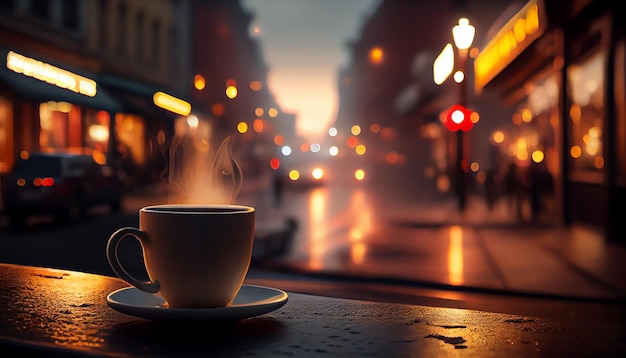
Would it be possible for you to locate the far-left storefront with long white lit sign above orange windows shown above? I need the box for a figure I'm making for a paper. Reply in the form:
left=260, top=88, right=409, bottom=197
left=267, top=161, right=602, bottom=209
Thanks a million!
left=0, top=49, right=122, bottom=172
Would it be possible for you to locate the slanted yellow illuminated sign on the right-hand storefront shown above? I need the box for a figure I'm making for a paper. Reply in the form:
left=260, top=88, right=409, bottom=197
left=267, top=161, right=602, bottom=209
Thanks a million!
left=474, top=0, right=546, bottom=92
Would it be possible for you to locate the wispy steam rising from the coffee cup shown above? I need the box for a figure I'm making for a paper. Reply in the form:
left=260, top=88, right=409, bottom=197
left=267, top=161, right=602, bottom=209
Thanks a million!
left=163, top=123, right=243, bottom=204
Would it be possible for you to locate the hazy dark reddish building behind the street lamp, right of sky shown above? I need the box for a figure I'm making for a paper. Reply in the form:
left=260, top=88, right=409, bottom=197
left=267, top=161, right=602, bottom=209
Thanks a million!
left=337, top=0, right=510, bottom=198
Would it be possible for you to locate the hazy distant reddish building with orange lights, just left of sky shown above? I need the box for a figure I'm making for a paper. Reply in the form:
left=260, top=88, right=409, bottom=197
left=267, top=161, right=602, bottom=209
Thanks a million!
left=191, top=1, right=285, bottom=185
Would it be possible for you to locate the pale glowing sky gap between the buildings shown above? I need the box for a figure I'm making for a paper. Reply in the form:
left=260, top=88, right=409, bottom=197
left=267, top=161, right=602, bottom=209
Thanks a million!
left=242, top=0, right=379, bottom=139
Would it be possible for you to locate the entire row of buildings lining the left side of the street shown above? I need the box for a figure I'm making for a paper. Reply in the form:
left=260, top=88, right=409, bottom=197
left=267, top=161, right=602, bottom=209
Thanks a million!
left=0, top=0, right=280, bottom=193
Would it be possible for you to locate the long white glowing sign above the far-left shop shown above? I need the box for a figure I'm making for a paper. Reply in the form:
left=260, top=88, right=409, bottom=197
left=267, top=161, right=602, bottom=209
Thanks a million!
left=7, top=51, right=97, bottom=97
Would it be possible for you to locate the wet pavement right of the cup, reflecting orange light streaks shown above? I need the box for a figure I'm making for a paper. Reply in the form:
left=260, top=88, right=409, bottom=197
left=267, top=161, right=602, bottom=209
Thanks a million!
left=127, top=179, right=626, bottom=302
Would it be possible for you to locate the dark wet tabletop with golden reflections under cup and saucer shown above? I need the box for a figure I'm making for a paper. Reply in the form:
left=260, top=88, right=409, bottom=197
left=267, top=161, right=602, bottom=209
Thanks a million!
left=0, top=264, right=626, bottom=357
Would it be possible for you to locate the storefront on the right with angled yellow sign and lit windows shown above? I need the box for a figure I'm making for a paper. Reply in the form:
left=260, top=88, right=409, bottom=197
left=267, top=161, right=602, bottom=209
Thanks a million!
left=475, top=0, right=626, bottom=240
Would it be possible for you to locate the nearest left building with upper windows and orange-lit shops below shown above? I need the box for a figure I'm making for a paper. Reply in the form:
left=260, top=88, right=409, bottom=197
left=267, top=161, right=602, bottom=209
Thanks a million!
left=0, top=0, right=190, bottom=189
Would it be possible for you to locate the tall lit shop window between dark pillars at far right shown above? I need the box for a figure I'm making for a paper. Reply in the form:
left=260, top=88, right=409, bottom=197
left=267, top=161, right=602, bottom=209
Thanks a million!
left=565, top=52, right=605, bottom=180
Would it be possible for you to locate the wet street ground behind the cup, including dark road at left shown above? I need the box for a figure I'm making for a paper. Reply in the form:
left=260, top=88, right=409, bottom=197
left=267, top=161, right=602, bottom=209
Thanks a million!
left=0, top=175, right=626, bottom=303
